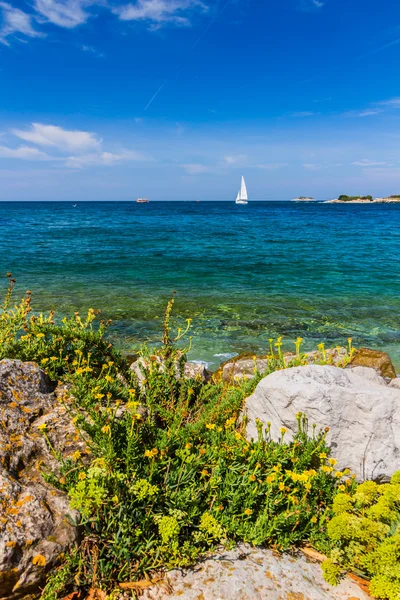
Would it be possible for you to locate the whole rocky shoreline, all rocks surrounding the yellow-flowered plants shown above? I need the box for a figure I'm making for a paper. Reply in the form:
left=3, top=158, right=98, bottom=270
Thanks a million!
left=0, top=348, right=400, bottom=600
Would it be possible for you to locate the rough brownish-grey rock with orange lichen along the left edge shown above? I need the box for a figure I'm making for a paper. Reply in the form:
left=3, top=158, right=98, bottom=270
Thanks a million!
left=0, top=360, right=81, bottom=600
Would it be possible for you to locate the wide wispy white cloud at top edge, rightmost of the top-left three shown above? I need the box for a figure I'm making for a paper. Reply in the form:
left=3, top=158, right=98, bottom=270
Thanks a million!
left=114, top=0, right=208, bottom=28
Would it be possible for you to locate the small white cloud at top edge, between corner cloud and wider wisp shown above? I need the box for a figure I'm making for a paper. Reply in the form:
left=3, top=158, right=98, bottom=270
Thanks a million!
left=34, top=0, right=94, bottom=29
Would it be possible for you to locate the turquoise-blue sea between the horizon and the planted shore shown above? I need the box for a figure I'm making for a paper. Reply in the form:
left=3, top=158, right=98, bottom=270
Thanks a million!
left=0, top=202, right=400, bottom=366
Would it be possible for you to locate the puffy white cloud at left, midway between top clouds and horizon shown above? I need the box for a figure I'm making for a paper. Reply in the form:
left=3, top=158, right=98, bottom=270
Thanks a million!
left=12, top=123, right=101, bottom=153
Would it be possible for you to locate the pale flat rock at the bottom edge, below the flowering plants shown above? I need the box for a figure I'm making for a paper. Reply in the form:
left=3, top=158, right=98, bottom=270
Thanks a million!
left=141, top=544, right=369, bottom=600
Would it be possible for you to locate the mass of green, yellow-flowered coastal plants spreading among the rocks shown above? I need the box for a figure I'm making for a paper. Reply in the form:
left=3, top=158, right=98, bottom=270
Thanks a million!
left=0, top=274, right=400, bottom=600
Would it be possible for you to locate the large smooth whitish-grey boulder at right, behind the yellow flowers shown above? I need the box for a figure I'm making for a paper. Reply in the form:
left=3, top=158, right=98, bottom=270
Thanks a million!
left=245, top=365, right=400, bottom=480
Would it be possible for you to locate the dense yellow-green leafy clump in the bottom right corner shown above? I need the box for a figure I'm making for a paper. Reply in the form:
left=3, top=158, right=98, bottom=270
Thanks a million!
left=323, top=471, right=400, bottom=600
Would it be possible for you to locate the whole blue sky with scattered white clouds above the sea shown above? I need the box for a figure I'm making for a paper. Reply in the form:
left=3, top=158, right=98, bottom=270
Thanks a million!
left=0, top=0, right=400, bottom=201
